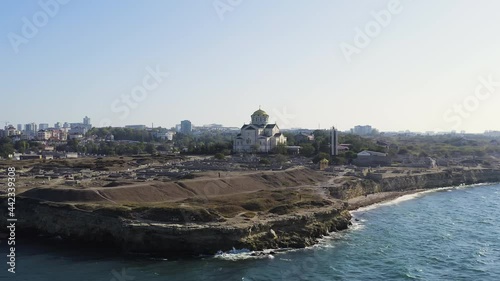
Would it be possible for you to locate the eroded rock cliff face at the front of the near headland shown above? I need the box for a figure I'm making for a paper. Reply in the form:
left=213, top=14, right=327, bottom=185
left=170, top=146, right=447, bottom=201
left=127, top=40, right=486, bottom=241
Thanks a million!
left=0, top=197, right=350, bottom=256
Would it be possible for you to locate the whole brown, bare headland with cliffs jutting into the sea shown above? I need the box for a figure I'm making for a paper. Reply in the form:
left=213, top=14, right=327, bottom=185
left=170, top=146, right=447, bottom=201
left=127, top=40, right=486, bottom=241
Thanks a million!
left=0, top=157, right=500, bottom=256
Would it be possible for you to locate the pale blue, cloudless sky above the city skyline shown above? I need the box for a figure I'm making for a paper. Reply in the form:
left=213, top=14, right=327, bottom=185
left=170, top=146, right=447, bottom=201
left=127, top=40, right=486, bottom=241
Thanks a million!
left=0, top=0, right=500, bottom=132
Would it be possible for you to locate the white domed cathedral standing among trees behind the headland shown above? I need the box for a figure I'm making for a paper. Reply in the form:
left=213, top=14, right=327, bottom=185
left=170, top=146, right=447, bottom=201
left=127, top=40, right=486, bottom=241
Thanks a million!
left=233, top=108, right=286, bottom=152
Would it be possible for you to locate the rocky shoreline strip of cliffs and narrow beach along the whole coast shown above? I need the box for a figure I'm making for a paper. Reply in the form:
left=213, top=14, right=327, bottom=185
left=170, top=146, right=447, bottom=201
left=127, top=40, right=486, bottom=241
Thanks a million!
left=0, top=166, right=500, bottom=256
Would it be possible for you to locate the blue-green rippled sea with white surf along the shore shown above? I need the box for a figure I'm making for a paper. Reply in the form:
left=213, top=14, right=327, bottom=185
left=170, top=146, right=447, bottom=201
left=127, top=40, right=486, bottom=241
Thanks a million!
left=0, top=184, right=500, bottom=281
